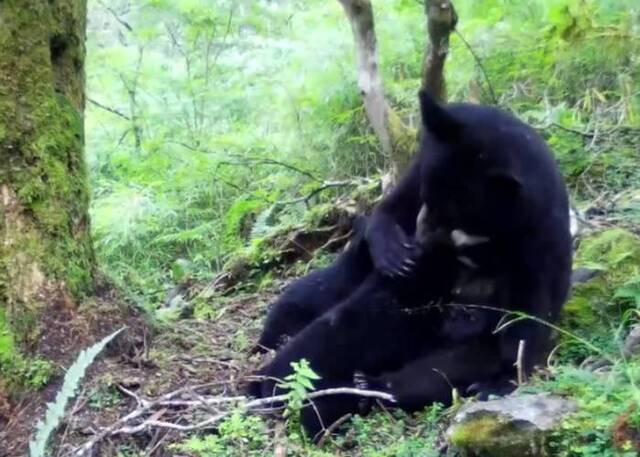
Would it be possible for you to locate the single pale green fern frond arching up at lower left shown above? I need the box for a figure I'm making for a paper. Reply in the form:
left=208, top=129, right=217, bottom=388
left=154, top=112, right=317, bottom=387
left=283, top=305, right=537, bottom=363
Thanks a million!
left=29, top=327, right=124, bottom=457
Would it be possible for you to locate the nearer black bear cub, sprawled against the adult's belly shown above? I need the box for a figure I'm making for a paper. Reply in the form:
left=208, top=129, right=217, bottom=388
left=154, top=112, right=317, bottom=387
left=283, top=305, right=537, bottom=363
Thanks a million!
left=249, top=232, right=457, bottom=437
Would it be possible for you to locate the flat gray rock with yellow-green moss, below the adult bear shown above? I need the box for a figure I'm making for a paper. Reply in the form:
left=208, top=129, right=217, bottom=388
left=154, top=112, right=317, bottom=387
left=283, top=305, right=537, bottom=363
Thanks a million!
left=447, top=394, right=577, bottom=457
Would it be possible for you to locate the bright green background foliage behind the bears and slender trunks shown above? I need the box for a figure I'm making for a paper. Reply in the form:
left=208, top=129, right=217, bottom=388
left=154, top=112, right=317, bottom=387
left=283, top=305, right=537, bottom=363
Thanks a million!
left=86, top=0, right=640, bottom=310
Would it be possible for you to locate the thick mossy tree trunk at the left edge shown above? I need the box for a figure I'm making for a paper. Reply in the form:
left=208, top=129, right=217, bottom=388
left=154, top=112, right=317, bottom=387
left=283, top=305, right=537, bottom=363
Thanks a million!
left=0, top=0, right=95, bottom=352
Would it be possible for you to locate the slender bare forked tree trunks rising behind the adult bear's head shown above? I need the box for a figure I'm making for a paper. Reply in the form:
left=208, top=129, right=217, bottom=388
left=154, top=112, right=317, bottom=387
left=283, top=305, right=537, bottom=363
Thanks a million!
left=339, top=0, right=457, bottom=183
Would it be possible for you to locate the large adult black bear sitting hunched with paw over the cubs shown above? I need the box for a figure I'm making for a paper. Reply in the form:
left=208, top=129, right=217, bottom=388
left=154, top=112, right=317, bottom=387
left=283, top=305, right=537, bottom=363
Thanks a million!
left=366, top=92, right=571, bottom=380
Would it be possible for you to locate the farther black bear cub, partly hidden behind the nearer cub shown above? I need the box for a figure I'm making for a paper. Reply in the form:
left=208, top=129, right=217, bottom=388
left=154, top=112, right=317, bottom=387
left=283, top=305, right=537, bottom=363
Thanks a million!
left=254, top=216, right=373, bottom=352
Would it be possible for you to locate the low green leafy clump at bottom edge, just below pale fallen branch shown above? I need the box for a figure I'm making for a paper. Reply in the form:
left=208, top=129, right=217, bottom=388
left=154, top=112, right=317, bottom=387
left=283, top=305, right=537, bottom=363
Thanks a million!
left=174, top=411, right=269, bottom=457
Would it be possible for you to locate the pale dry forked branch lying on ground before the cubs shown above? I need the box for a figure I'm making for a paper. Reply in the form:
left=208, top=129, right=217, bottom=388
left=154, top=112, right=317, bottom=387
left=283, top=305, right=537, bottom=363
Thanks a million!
left=74, top=384, right=395, bottom=457
